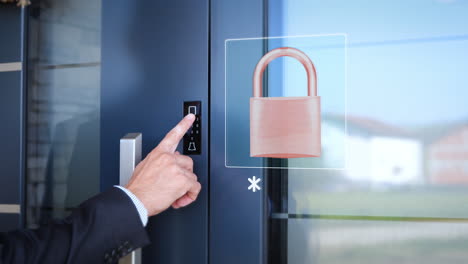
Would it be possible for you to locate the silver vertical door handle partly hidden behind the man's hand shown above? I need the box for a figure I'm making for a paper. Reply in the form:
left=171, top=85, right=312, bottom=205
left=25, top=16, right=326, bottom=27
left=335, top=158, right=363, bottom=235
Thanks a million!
left=119, top=133, right=142, bottom=264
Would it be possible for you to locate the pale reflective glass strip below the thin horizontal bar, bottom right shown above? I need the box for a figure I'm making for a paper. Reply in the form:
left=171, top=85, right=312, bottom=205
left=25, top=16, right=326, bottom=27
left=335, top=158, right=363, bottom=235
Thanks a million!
left=287, top=219, right=468, bottom=264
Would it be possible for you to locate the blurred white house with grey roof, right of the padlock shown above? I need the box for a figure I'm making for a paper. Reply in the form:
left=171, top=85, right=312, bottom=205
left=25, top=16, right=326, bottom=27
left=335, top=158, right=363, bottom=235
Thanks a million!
left=324, top=116, right=424, bottom=184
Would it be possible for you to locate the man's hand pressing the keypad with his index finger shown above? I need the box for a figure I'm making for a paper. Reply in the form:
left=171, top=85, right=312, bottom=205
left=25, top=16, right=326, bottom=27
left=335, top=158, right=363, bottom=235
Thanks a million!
left=126, top=114, right=201, bottom=216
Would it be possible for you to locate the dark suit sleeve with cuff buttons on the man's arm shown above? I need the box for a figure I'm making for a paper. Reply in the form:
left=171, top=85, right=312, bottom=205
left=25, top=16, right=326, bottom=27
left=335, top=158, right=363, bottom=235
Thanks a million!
left=0, top=188, right=149, bottom=264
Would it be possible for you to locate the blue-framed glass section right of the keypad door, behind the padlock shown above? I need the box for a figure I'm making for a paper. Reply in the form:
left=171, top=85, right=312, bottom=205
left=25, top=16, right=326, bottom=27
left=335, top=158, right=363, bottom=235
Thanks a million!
left=210, top=0, right=468, bottom=264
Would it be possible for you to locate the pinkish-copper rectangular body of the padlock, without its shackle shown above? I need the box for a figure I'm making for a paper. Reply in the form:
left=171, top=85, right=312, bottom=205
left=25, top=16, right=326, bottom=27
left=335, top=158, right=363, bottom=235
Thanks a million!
left=250, top=96, right=322, bottom=158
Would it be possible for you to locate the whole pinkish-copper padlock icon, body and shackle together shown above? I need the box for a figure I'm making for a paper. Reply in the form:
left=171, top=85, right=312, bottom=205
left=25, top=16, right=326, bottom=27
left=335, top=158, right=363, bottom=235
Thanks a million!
left=250, top=47, right=322, bottom=158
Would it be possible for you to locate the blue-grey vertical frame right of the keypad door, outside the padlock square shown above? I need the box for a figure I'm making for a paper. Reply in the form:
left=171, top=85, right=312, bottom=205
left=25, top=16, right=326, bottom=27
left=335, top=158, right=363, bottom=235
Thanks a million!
left=209, top=0, right=267, bottom=264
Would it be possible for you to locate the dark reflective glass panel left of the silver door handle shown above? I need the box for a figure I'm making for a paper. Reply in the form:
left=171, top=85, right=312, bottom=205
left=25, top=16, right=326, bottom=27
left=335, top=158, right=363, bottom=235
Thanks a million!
left=26, top=0, right=101, bottom=227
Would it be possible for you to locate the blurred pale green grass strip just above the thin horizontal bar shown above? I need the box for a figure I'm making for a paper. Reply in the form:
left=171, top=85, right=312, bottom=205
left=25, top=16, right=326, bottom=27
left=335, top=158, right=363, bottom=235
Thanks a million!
left=289, top=191, right=468, bottom=220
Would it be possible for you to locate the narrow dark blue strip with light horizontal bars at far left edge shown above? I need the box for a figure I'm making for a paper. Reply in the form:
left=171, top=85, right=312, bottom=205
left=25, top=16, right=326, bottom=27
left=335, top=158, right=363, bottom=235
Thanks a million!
left=0, top=4, right=27, bottom=232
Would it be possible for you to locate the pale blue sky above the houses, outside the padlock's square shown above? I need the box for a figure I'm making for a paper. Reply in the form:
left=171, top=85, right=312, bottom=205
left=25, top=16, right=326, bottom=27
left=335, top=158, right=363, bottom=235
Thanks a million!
left=276, top=0, right=468, bottom=127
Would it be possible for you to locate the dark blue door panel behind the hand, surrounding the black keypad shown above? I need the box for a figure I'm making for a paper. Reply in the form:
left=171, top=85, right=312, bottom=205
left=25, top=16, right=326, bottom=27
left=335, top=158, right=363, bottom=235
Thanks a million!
left=101, top=0, right=209, bottom=263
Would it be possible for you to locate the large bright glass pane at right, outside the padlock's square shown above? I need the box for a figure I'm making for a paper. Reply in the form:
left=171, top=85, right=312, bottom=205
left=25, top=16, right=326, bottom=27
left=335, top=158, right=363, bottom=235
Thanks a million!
left=267, top=0, right=468, bottom=263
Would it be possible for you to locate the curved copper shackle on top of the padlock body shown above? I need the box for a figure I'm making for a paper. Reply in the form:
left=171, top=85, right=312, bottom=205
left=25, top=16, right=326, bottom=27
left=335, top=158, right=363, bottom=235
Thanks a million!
left=253, top=47, right=317, bottom=97
